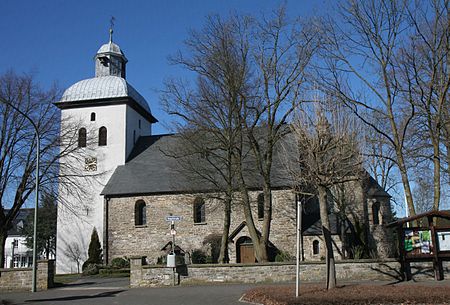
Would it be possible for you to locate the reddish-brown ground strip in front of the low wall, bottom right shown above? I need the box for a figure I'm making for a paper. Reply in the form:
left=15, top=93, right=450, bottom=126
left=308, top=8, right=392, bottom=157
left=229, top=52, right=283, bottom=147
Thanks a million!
left=243, top=283, right=450, bottom=305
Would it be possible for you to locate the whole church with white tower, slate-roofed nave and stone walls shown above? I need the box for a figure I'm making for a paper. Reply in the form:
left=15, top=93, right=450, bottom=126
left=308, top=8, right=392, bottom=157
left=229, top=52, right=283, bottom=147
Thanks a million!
left=56, top=31, right=392, bottom=273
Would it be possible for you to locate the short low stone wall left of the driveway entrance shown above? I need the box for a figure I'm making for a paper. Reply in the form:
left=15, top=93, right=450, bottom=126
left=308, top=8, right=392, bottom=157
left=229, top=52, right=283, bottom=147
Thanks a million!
left=0, top=260, right=55, bottom=291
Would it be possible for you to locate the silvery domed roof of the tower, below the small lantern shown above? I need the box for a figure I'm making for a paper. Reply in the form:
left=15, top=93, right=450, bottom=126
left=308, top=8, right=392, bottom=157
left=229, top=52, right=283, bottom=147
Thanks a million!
left=57, top=76, right=151, bottom=114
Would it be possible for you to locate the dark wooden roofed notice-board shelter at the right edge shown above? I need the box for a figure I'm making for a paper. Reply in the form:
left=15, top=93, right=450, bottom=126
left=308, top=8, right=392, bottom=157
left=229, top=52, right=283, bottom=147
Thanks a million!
left=387, top=211, right=450, bottom=281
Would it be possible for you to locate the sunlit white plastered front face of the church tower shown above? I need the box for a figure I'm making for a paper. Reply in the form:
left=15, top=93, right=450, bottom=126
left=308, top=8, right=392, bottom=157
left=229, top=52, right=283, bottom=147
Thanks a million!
left=56, top=104, right=128, bottom=273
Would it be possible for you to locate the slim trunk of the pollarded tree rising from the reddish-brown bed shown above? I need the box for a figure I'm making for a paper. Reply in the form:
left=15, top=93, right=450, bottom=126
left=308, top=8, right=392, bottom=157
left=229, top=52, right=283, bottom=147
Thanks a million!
left=319, top=186, right=336, bottom=289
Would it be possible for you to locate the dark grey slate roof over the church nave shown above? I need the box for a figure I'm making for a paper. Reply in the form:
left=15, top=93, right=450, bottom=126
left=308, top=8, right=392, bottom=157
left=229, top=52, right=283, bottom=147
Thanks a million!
left=101, top=135, right=291, bottom=197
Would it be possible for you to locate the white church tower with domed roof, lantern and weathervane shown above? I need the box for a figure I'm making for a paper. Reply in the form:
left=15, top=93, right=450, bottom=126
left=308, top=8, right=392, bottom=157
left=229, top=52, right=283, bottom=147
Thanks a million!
left=55, top=30, right=157, bottom=273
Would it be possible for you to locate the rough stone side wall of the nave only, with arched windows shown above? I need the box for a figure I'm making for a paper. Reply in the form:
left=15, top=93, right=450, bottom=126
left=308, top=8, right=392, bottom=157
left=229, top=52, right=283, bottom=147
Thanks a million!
left=108, top=190, right=296, bottom=263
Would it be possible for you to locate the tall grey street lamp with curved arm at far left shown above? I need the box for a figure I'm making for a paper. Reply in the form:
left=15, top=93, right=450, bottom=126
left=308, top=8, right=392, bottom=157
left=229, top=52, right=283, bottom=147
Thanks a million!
left=0, top=98, right=41, bottom=292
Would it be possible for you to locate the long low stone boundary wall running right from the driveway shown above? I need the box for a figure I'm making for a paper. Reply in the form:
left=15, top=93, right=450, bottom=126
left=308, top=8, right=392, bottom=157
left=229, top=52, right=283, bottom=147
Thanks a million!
left=130, top=258, right=450, bottom=288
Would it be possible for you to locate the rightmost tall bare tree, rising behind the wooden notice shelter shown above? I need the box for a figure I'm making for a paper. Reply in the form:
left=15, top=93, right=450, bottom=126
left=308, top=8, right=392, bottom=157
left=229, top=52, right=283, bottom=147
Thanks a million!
left=399, top=0, right=450, bottom=210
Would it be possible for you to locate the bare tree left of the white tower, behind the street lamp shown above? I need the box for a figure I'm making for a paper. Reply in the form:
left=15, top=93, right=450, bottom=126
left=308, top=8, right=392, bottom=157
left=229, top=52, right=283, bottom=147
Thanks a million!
left=0, top=71, right=98, bottom=265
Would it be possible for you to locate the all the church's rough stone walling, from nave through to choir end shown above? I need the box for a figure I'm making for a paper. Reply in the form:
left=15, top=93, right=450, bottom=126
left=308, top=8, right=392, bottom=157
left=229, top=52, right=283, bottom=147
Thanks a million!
left=104, top=182, right=395, bottom=264
